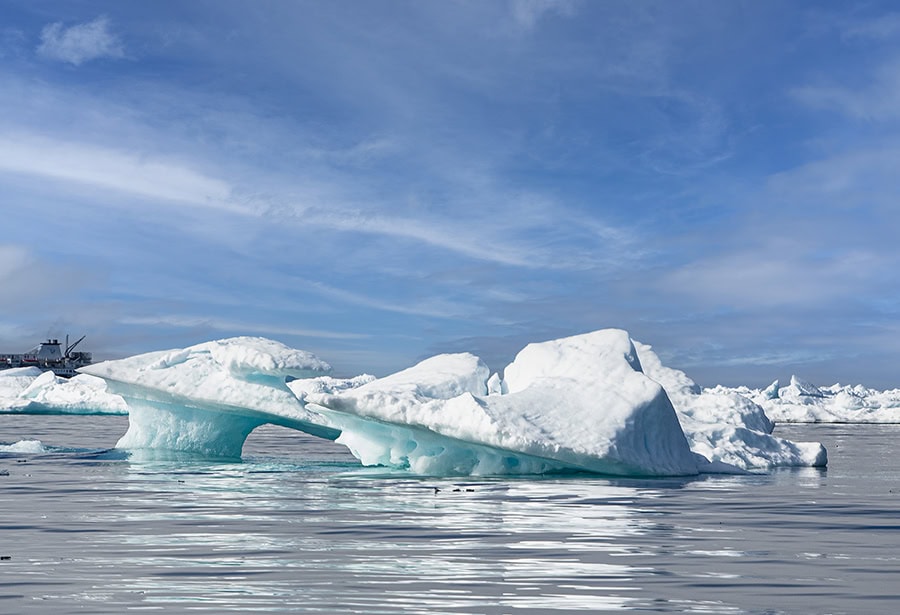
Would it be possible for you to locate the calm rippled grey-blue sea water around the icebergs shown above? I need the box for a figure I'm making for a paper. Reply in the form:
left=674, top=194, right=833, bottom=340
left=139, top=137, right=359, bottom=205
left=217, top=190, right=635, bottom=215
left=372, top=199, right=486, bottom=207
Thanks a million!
left=0, top=415, right=900, bottom=615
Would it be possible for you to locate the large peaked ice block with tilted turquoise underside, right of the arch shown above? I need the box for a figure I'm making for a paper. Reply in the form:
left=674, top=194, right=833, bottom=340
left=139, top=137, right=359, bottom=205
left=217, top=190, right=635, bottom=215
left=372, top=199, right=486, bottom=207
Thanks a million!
left=306, top=329, right=697, bottom=475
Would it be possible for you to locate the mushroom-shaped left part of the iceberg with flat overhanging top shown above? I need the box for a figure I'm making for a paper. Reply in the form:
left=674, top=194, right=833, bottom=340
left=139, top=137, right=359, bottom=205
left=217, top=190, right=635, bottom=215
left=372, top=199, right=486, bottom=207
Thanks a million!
left=80, top=337, right=338, bottom=457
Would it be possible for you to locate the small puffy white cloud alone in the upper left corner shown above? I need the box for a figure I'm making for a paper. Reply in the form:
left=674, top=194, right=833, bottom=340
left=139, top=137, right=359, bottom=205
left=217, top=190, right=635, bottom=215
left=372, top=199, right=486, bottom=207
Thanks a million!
left=37, top=17, right=125, bottom=66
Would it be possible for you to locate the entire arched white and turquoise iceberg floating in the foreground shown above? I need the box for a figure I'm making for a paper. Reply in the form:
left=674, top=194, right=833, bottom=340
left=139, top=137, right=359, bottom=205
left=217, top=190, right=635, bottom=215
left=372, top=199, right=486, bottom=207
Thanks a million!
left=82, top=330, right=825, bottom=475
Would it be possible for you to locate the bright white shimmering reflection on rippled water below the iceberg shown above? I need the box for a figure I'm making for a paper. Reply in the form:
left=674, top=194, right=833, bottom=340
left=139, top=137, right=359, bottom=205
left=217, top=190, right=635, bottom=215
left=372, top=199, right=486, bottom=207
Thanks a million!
left=88, top=458, right=700, bottom=612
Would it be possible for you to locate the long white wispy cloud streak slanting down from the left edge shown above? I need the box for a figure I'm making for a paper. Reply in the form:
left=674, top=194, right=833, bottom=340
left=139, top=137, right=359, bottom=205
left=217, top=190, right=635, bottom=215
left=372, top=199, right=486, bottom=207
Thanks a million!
left=0, top=127, right=638, bottom=276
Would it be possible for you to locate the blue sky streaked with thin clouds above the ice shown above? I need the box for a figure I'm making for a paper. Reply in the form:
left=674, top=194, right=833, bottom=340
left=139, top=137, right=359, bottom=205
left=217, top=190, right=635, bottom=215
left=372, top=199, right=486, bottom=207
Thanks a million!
left=0, top=0, right=900, bottom=388
